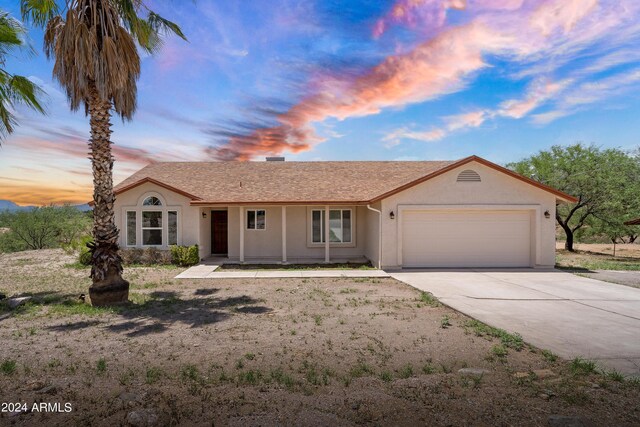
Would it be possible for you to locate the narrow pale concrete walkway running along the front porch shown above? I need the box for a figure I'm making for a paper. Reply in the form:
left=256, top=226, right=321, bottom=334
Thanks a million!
left=176, top=264, right=390, bottom=279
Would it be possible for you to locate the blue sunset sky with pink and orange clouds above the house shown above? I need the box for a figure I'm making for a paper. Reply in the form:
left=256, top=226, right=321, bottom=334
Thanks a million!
left=0, top=0, right=640, bottom=204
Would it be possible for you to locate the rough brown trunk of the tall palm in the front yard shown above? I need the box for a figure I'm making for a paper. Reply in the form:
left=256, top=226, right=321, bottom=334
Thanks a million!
left=87, top=84, right=129, bottom=306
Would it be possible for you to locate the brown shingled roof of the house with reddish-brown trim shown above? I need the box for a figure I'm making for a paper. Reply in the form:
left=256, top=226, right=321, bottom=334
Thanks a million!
left=115, top=156, right=572, bottom=205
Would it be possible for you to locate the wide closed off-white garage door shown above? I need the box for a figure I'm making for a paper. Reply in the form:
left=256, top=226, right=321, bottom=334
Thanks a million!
left=402, top=210, right=531, bottom=267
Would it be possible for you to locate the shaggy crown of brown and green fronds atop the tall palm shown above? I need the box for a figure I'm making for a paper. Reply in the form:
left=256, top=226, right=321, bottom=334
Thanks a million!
left=21, top=0, right=186, bottom=120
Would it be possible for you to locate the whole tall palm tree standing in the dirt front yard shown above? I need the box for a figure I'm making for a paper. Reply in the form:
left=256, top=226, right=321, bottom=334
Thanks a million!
left=20, top=0, right=186, bottom=305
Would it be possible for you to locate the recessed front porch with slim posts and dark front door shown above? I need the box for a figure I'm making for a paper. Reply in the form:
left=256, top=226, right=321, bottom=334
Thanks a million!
left=199, top=205, right=379, bottom=267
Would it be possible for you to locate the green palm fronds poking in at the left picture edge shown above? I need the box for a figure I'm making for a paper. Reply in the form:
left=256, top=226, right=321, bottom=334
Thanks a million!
left=0, top=10, right=44, bottom=143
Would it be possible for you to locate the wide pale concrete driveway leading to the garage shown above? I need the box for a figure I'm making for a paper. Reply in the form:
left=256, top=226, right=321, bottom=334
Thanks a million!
left=391, top=270, right=640, bottom=375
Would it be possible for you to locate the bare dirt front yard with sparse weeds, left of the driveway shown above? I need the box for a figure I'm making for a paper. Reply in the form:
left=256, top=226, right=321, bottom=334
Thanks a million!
left=0, top=250, right=640, bottom=426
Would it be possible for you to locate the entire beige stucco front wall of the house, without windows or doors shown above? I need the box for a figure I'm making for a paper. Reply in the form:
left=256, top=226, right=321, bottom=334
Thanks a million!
left=115, top=162, right=556, bottom=268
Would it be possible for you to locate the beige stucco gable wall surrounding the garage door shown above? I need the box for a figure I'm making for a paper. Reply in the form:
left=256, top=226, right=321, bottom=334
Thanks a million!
left=382, top=162, right=556, bottom=268
